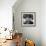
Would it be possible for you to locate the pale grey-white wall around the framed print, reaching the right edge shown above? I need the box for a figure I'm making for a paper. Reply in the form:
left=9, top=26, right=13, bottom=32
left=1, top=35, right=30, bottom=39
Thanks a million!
left=13, top=0, right=46, bottom=46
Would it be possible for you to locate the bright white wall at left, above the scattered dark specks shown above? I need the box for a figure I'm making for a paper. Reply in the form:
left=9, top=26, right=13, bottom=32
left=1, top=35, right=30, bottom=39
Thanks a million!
left=0, top=0, right=16, bottom=29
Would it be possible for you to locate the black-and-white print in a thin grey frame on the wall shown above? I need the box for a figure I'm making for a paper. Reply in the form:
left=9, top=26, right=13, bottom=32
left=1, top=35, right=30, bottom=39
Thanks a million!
left=21, top=12, right=36, bottom=27
